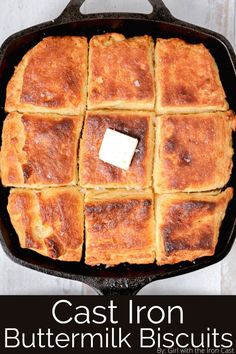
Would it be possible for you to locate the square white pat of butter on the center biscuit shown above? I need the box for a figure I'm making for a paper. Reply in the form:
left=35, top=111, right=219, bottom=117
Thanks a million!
left=99, top=128, right=138, bottom=170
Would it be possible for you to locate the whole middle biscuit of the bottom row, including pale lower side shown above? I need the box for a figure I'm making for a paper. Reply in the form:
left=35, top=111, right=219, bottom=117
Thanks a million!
left=85, top=190, right=155, bottom=266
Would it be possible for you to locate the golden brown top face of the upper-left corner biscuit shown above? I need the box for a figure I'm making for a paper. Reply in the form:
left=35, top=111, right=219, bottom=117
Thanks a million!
left=20, top=36, right=87, bottom=109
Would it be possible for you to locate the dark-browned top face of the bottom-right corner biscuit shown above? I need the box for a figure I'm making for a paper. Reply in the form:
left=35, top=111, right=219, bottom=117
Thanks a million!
left=157, top=188, right=233, bottom=255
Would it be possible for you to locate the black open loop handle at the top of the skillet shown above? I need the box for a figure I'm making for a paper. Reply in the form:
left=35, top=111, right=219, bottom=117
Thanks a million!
left=55, top=0, right=175, bottom=23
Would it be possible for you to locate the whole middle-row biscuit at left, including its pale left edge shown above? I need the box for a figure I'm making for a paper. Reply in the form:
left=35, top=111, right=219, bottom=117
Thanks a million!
left=0, top=113, right=83, bottom=188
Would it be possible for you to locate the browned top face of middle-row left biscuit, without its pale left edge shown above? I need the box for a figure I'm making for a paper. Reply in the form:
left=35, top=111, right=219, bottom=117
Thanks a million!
left=22, top=115, right=76, bottom=183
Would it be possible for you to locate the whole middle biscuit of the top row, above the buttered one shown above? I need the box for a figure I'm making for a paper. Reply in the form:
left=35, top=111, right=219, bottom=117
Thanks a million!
left=88, top=33, right=155, bottom=110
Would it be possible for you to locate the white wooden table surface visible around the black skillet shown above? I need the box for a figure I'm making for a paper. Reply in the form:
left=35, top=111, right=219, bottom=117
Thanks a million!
left=0, top=0, right=236, bottom=295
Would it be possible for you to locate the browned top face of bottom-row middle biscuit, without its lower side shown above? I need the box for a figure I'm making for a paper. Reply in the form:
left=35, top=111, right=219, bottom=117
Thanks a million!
left=85, top=193, right=153, bottom=251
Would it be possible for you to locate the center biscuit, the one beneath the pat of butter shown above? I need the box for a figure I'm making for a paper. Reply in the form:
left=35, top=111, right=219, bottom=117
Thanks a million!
left=79, top=111, right=154, bottom=188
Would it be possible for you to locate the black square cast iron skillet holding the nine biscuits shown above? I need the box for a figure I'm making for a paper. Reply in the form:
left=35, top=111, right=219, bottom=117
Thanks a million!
left=0, top=0, right=236, bottom=295
